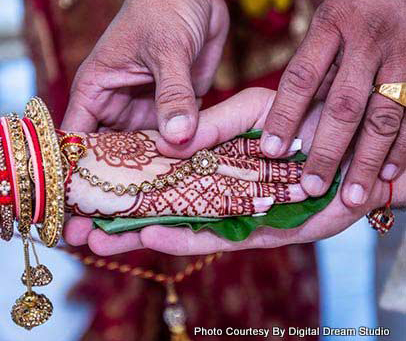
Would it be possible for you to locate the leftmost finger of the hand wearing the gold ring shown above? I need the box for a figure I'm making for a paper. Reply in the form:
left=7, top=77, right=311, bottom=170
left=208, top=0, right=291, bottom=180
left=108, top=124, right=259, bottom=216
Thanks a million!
left=261, top=17, right=340, bottom=157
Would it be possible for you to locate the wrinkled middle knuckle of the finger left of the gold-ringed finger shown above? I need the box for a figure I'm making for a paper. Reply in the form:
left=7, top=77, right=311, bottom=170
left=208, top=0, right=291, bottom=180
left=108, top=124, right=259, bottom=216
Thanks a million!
left=327, top=87, right=364, bottom=125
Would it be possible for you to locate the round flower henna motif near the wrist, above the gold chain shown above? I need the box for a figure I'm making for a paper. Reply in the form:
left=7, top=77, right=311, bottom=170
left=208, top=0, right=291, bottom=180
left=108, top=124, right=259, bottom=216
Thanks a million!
left=85, top=132, right=160, bottom=170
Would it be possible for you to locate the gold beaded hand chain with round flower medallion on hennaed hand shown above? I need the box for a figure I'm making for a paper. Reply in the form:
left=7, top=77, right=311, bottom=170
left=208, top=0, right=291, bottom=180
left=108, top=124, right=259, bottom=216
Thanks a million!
left=75, top=149, right=218, bottom=196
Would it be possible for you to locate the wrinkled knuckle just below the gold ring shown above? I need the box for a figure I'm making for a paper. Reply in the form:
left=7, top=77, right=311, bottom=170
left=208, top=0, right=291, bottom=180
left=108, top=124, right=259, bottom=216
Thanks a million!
left=365, top=106, right=402, bottom=138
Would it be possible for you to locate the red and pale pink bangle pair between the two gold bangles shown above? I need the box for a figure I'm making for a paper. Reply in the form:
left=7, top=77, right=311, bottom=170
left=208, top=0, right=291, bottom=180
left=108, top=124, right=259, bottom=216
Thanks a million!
left=21, top=117, right=45, bottom=224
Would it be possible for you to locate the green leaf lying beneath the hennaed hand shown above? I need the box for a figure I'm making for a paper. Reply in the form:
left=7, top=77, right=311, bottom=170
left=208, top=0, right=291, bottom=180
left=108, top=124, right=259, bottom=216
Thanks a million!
left=93, top=130, right=340, bottom=241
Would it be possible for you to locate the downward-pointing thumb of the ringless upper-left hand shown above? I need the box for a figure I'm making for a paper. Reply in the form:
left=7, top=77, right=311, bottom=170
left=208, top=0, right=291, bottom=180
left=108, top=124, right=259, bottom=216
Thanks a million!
left=154, top=62, right=199, bottom=144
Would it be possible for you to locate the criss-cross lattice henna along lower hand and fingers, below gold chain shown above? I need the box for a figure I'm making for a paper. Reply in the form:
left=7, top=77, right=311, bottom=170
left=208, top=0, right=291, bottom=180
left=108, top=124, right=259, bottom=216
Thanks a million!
left=124, top=174, right=306, bottom=217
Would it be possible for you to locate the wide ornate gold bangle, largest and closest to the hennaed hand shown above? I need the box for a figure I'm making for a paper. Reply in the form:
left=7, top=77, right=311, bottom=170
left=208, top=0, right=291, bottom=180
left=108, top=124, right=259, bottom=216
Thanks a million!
left=25, top=97, right=64, bottom=247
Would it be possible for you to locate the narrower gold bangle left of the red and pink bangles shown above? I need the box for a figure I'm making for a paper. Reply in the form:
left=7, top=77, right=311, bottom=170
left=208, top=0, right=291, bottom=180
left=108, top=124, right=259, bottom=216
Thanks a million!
left=7, top=114, right=32, bottom=236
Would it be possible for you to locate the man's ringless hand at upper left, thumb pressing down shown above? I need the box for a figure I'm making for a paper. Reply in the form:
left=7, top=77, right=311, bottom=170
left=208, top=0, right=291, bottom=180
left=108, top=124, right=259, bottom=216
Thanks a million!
left=62, top=0, right=229, bottom=144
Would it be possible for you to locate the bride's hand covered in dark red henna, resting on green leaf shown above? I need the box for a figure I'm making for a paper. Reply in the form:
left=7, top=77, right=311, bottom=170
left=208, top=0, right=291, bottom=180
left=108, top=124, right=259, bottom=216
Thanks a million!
left=66, top=131, right=307, bottom=217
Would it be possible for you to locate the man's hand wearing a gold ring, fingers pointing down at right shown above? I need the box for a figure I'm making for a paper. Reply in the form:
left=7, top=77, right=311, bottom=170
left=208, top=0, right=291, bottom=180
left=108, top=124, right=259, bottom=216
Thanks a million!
left=262, top=0, right=406, bottom=207
